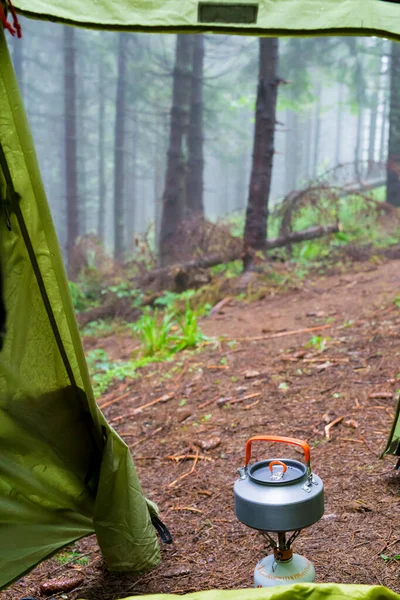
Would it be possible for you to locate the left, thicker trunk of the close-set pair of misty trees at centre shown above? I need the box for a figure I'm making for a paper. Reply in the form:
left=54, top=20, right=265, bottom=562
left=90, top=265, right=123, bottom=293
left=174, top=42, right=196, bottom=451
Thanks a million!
left=160, top=34, right=193, bottom=266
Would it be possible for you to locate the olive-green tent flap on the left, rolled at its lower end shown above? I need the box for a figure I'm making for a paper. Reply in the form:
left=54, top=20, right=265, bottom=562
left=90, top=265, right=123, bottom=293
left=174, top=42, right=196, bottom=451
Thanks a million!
left=0, top=31, right=160, bottom=588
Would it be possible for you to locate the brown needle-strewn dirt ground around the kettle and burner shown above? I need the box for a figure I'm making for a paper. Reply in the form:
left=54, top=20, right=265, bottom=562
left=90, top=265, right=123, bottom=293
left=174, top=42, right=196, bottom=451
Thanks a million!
left=1, top=261, right=400, bottom=600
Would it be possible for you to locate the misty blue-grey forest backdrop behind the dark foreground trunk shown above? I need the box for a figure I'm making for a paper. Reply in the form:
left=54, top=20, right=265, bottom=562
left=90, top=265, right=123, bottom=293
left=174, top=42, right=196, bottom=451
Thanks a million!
left=7, top=20, right=400, bottom=278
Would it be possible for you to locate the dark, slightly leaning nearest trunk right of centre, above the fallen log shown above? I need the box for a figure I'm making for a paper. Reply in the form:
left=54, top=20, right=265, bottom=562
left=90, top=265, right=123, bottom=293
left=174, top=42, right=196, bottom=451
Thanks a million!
left=243, top=38, right=278, bottom=269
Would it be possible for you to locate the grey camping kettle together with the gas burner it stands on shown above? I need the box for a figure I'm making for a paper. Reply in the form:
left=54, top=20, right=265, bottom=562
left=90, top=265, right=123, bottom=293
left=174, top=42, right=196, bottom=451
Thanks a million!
left=234, top=435, right=324, bottom=587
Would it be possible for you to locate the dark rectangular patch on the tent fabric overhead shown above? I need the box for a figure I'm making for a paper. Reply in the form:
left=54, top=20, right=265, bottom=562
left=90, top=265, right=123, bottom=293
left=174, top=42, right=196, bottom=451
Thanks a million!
left=198, top=2, right=258, bottom=25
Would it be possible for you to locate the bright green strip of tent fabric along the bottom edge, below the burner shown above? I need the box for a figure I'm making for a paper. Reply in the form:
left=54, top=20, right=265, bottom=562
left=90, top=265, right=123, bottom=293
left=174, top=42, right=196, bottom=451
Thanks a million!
left=125, top=583, right=400, bottom=600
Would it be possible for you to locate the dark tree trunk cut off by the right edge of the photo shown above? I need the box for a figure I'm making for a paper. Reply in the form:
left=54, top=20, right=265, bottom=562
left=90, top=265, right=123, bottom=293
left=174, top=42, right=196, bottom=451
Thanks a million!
left=386, top=42, right=400, bottom=206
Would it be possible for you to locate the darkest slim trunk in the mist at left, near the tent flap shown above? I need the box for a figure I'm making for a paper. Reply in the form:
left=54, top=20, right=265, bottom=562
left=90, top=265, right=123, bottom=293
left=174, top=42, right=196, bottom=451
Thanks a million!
left=63, top=27, right=79, bottom=280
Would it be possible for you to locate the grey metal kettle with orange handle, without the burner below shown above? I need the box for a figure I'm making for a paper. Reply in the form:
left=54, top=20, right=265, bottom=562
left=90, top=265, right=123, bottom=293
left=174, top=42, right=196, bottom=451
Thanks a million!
left=234, top=435, right=324, bottom=532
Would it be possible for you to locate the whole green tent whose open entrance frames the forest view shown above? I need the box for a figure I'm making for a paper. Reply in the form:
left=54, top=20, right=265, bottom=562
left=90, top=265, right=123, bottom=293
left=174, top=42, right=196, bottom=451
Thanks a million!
left=0, top=0, right=400, bottom=600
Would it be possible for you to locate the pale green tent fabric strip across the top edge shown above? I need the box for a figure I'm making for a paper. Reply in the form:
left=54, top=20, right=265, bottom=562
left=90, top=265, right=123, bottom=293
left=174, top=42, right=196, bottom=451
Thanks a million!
left=10, top=0, right=400, bottom=39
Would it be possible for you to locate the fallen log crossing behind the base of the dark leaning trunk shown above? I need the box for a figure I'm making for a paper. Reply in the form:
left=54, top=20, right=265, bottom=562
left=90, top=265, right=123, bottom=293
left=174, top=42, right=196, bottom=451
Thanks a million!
left=140, top=223, right=340, bottom=286
